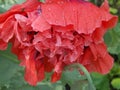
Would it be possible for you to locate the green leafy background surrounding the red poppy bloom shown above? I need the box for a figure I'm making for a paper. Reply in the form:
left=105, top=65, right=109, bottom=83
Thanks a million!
left=0, top=0, right=120, bottom=90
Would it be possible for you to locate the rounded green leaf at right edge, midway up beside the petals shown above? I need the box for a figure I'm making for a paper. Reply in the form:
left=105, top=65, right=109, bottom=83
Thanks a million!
left=104, top=23, right=120, bottom=54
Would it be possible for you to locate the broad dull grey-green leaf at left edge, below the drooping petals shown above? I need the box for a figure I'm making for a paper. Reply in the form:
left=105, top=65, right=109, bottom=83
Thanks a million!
left=0, top=47, right=19, bottom=83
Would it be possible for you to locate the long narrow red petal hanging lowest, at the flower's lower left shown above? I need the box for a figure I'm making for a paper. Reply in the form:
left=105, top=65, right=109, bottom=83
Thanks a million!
left=25, top=49, right=38, bottom=86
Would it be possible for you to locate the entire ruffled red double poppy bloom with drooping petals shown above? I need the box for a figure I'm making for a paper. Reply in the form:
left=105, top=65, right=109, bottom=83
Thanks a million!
left=0, top=0, right=117, bottom=85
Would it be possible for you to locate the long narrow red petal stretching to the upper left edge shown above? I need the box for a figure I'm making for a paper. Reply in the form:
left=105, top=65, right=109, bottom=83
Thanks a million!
left=0, top=0, right=40, bottom=23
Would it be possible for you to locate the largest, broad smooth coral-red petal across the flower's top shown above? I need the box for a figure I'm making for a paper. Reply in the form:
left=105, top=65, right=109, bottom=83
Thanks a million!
left=41, top=2, right=117, bottom=34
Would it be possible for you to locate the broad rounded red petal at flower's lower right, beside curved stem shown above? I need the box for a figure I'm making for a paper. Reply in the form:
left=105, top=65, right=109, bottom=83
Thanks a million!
left=80, top=43, right=113, bottom=74
